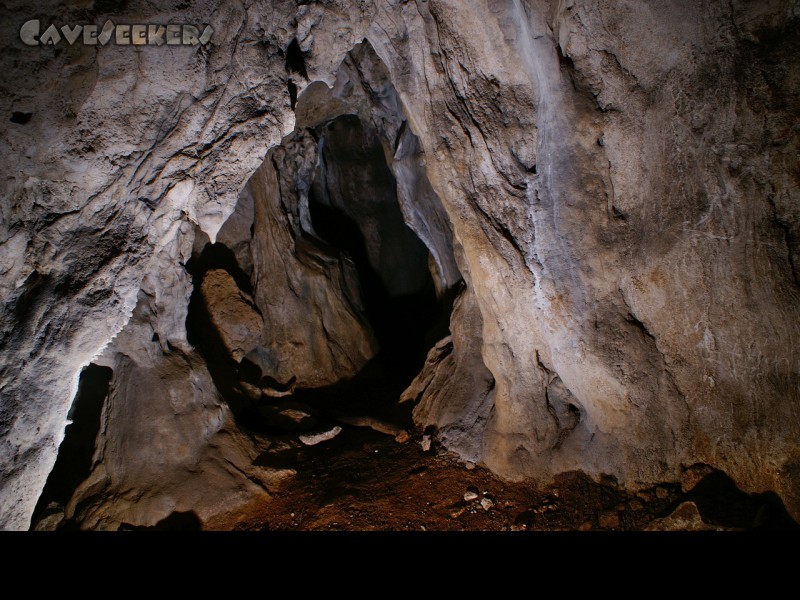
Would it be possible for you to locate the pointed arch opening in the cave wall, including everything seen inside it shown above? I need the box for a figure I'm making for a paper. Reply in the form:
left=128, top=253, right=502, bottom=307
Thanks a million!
left=187, top=45, right=462, bottom=432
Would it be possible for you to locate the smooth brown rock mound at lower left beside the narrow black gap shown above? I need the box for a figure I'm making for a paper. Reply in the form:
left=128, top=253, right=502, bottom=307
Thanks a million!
left=56, top=294, right=290, bottom=529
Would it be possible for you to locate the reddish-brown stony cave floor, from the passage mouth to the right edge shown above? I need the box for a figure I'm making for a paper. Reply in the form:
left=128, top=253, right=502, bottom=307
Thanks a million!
left=186, top=356, right=798, bottom=531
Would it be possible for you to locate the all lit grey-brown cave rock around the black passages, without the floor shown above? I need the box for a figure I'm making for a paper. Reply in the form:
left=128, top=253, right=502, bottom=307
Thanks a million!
left=0, top=0, right=800, bottom=529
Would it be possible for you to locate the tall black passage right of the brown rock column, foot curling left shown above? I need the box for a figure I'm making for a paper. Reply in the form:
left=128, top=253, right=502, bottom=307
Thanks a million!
left=286, top=114, right=461, bottom=428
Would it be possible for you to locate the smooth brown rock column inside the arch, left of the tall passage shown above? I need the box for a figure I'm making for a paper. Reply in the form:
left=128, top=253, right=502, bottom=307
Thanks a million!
left=248, top=135, right=377, bottom=387
